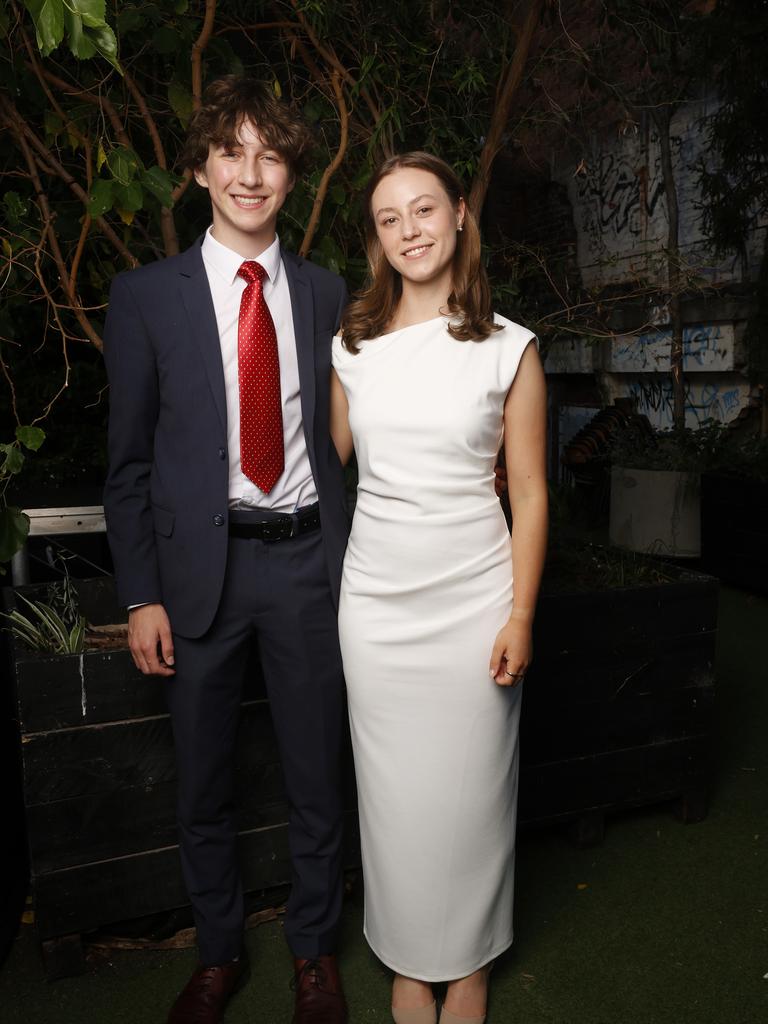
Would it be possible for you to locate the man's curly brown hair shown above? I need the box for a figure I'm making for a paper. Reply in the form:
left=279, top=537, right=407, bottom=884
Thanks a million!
left=179, top=75, right=314, bottom=175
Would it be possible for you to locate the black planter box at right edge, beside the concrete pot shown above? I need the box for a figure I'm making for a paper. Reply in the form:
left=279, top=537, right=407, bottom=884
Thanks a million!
left=701, top=473, right=768, bottom=594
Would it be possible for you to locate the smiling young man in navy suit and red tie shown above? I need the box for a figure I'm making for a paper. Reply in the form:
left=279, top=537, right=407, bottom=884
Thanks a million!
left=104, top=76, right=348, bottom=1024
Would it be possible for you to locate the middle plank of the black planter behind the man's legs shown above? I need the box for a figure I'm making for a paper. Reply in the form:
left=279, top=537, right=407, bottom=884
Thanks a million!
left=26, top=705, right=356, bottom=873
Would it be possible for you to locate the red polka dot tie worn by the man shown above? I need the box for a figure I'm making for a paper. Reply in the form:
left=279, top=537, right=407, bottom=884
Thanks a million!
left=238, top=260, right=285, bottom=494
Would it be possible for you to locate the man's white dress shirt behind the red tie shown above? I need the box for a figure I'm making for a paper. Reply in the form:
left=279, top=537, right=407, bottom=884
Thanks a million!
left=203, top=228, right=317, bottom=512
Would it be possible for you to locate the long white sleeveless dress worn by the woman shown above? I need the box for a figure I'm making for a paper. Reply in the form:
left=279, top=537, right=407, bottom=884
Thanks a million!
left=333, top=316, right=532, bottom=981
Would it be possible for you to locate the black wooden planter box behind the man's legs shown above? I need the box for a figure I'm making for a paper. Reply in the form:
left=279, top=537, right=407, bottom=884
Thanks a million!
left=5, top=579, right=358, bottom=976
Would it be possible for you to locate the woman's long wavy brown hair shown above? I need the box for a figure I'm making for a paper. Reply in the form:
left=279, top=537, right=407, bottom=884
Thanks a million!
left=341, top=151, right=501, bottom=352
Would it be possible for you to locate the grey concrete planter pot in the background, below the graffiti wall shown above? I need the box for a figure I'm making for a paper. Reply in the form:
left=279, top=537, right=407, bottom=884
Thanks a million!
left=608, top=466, right=701, bottom=558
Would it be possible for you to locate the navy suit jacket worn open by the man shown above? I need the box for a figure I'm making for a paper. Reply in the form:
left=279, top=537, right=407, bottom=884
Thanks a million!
left=104, top=239, right=349, bottom=637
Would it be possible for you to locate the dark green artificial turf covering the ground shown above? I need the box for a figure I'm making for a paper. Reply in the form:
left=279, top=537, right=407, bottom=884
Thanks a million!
left=0, top=590, right=768, bottom=1024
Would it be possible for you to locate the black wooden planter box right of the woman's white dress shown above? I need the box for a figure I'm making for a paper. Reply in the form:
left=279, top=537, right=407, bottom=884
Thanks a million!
left=519, top=567, right=718, bottom=843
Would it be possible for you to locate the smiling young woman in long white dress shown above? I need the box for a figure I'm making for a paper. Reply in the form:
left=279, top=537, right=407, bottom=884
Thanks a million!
left=332, top=153, right=547, bottom=1024
